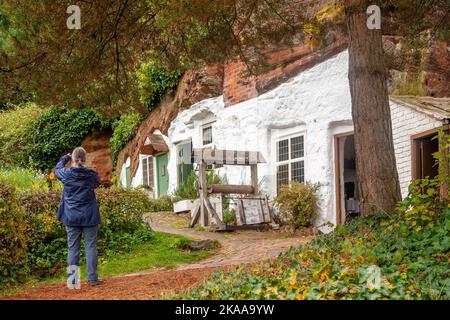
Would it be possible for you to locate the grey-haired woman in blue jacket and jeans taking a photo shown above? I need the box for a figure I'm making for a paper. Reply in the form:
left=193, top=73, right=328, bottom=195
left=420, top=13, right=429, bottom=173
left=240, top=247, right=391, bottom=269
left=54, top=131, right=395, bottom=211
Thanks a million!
left=55, top=147, right=103, bottom=285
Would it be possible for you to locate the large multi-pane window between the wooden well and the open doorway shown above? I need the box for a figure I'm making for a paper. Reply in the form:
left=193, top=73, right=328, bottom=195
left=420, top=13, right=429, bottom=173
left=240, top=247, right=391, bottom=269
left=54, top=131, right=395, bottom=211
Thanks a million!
left=276, top=136, right=305, bottom=193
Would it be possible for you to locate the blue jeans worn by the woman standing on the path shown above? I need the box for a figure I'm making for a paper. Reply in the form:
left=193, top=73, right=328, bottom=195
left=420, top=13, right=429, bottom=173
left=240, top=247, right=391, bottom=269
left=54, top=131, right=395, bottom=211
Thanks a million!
left=66, top=226, right=98, bottom=281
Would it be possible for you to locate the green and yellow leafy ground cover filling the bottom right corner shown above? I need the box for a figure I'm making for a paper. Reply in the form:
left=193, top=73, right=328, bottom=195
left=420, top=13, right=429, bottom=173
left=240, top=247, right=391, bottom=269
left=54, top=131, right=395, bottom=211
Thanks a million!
left=182, top=209, right=450, bottom=300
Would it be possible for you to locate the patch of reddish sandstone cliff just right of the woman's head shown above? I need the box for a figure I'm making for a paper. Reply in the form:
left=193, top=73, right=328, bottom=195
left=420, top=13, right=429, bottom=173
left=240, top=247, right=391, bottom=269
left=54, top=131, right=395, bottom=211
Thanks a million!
left=81, top=130, right=113, bottom=185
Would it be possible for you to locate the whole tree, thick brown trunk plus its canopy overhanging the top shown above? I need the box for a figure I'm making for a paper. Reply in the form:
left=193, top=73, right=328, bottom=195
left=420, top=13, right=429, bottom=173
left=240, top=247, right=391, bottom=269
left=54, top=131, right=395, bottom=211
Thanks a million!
left=0, top=0, right=450, bottom=214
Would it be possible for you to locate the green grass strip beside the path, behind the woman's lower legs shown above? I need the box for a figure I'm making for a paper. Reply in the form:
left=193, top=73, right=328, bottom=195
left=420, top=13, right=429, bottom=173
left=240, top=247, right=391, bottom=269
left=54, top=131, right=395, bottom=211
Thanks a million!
left=0, top=232, right=213, bottom=296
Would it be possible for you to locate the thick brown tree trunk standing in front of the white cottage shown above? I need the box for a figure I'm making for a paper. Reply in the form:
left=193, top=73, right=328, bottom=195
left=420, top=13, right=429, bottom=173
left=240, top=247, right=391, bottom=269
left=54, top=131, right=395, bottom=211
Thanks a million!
left=345, top=0, right=401, bottom=215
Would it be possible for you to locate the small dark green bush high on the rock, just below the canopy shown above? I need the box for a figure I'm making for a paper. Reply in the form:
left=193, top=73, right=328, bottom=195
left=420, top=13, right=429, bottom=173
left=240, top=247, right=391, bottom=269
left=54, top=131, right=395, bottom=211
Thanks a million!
left=140, top=61, right=182, bottom=111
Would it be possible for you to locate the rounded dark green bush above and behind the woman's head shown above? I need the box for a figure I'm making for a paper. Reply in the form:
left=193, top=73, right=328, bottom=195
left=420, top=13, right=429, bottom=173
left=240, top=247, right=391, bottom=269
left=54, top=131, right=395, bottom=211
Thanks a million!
left=28, top=107, right=109, bottom=171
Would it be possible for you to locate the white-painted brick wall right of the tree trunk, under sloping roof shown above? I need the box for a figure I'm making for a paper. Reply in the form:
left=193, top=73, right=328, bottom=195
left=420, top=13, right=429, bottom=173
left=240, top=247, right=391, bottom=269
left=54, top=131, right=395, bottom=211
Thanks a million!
left=391, top=102, right=442, bottom=197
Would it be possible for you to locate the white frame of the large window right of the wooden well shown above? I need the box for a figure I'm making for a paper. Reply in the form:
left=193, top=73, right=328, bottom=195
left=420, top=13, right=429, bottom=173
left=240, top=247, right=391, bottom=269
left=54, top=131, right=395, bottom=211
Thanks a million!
left=272, top=129, right=307, bottom=196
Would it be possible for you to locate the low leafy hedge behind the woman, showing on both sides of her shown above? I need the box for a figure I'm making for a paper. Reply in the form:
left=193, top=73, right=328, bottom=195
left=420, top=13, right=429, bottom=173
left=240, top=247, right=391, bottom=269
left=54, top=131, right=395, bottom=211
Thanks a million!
left=0, top=183, right=157, bottom=286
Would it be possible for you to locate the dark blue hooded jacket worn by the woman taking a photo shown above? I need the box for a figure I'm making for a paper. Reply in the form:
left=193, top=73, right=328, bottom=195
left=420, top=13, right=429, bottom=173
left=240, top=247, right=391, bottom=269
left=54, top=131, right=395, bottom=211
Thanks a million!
left=55, top=155, right=101, bottom=227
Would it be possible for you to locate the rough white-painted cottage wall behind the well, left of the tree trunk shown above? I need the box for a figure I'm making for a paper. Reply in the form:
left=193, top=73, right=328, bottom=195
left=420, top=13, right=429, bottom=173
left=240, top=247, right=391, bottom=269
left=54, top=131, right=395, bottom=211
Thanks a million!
left=168, top=51, right=351, bottom=228
